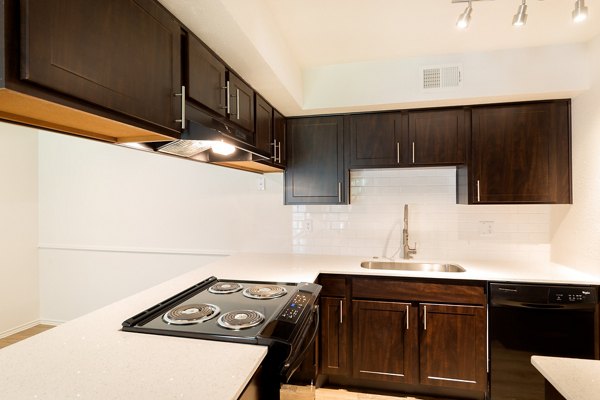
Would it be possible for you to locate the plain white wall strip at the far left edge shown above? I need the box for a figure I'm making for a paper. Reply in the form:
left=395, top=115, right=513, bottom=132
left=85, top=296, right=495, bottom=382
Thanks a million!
left=0, top=123, right=39, bottom=336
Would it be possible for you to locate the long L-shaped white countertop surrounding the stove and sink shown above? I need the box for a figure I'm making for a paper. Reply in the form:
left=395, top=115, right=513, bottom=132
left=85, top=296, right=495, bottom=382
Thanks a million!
left=0, top=254, right=600, bottom=400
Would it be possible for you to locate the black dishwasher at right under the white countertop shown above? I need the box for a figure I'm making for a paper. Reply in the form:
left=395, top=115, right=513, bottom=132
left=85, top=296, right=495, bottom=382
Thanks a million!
left=489, top=283, right=598, bottom=400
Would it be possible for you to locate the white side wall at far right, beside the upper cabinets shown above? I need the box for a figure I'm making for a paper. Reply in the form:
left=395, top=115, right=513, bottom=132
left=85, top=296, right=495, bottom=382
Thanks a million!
left=552, top=37, right=600, bottom=274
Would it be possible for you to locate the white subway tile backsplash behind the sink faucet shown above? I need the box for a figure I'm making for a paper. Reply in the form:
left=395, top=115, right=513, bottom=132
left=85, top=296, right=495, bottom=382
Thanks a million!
left=292, top=167, right=553, bottom=261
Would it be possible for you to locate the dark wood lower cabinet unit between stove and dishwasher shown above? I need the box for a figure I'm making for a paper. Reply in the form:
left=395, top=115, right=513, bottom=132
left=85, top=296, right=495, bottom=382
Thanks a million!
left=318, top=277, right=488, bottom=399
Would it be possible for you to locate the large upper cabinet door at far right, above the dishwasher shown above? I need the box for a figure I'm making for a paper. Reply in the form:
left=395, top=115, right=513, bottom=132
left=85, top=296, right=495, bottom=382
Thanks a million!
left=469, top=101, right=571, bottom=203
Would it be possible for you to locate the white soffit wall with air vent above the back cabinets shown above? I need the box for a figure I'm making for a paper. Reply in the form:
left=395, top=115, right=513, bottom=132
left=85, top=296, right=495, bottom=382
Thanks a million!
left=303, top=44, right=590, bottom=113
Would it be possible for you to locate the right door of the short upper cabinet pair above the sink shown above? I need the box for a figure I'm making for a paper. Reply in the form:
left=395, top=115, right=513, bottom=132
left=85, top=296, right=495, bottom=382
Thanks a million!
left=408, top=109, right=466, bottom=165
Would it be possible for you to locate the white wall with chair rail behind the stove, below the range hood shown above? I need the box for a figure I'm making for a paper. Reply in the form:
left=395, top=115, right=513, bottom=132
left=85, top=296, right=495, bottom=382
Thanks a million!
left=39, top=131, right=291, bottom=321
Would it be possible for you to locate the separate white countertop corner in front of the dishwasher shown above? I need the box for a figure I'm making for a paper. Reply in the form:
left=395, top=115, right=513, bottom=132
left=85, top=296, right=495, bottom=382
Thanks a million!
left=531, top=356, right=600, bottom=400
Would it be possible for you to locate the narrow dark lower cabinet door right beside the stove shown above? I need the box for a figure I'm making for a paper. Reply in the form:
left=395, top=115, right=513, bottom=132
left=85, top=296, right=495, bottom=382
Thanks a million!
left=319, top=297, right=350, bottom=375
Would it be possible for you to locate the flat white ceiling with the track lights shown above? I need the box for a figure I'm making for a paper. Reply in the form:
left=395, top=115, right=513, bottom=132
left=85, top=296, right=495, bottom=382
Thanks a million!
left=266, top=0, right=600, bottom=67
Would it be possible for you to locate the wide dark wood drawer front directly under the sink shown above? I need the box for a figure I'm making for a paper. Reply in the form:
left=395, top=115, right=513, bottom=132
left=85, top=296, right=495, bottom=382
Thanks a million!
left=352, top=278, right=485, bottom=304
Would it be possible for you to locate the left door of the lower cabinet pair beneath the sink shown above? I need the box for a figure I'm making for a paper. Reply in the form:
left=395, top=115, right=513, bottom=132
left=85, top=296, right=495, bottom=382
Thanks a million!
left=352, top=300, right=417, bottom=383
